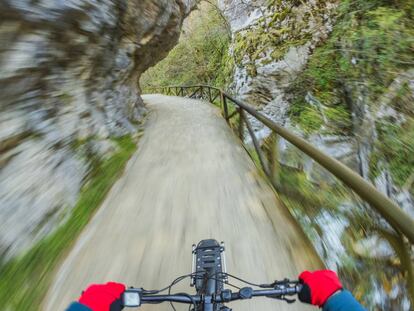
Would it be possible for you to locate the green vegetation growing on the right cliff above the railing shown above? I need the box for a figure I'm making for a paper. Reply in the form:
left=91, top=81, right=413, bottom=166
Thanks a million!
left=289, top=0, right=414, bottom=192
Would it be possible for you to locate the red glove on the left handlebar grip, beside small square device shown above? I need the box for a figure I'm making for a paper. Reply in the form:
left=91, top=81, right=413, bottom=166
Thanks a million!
left=79, top=282, right=125, bottom=311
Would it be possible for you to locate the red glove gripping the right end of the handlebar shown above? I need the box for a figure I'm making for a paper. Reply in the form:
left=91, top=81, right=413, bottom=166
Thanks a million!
left=298, top=270, right=342, bottom=307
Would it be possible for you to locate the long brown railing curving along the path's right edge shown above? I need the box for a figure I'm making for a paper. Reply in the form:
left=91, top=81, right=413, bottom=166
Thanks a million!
left=148, top=85, right=414, bottom=244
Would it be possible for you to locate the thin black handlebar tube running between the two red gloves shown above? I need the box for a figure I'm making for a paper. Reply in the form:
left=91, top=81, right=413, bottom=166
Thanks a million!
left=141, top=284, right=302, bottom=304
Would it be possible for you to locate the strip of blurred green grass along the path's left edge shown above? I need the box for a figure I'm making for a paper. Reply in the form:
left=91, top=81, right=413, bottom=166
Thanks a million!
left=0, top=136, right=136, bottom=310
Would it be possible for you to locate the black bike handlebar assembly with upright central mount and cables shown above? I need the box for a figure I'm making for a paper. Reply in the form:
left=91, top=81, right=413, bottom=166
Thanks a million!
left=122, top=239, right=302, bottom=311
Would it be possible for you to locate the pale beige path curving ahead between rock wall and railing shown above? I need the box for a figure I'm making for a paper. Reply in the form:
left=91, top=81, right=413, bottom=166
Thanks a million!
left=45, top=95, right=319, bottom=311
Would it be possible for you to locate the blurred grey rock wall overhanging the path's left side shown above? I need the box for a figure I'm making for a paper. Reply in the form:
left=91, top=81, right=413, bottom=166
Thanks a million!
left=0, top=0, right=194, bottom=261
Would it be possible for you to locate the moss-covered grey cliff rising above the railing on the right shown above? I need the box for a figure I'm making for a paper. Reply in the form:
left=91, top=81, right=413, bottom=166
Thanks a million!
left=219, top=0, right=414, bottom=215
